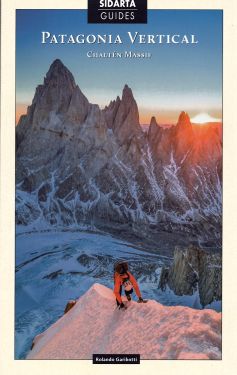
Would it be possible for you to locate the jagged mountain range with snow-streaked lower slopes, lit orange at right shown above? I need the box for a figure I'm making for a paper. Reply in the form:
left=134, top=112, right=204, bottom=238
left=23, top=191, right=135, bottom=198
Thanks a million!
left=16, top=60, right=222, bottom=247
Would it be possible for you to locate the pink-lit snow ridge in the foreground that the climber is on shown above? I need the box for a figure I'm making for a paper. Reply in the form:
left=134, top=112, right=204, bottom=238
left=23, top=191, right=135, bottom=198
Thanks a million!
left=27, top=284, right=221, bottom=359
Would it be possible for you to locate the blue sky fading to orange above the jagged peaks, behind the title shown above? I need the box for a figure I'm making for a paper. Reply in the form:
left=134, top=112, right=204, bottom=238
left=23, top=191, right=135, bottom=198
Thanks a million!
left=16, top=9, right=222, bottom=124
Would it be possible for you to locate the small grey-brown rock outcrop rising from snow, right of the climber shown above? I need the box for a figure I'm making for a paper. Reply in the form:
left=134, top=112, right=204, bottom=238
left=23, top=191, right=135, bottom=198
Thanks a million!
left=159, top=245, right=222, bottom=306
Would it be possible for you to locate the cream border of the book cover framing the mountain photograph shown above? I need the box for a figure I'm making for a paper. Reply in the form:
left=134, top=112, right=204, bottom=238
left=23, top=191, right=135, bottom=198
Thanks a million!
left=0, top=0, right=237, bottom=375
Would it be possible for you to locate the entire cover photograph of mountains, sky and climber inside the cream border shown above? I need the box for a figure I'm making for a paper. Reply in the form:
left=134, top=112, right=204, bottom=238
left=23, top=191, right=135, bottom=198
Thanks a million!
left=14, top=0, right=223, bottom=364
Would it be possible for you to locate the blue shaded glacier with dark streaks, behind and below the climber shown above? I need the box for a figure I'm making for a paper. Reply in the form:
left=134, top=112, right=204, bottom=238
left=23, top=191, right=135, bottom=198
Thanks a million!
left=15, top=231, right=221, bottom=358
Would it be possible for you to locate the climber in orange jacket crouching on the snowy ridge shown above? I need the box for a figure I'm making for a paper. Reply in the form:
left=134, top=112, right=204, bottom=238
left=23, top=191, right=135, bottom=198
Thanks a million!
left=114, top=262, right=143, bottom=309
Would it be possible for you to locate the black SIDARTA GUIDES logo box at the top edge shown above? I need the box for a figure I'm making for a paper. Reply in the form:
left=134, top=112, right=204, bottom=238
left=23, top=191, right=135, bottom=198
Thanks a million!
left=88, top=0, right=147, bottom=23
